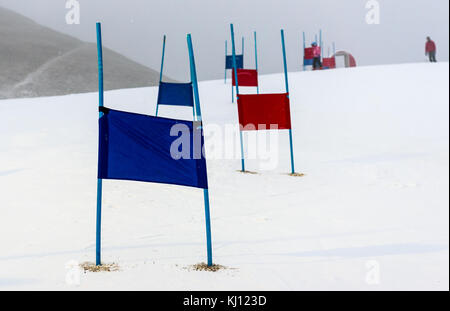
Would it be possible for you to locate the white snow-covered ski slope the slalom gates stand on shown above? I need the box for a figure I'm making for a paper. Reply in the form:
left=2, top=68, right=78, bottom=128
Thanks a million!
left=0, top=63, right=449, bottom=290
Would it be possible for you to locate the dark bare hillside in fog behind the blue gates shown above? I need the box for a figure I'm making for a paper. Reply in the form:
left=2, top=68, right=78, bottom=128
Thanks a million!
left=0, top=8, right=169, bottom=99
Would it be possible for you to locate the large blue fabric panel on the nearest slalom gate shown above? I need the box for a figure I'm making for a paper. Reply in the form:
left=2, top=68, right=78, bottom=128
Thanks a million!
left=98, top=108, right=208, bottom=189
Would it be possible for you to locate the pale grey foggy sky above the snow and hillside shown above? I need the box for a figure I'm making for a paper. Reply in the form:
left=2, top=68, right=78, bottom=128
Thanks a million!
left=0, top=0, right=449, bottom=80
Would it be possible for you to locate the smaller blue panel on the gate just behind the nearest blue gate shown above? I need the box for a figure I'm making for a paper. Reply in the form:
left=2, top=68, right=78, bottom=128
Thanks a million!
left=158, top=82, right=194, bottom=107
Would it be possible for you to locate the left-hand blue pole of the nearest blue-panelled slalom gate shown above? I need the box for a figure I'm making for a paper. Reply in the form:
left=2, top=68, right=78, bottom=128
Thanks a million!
left=95, top=23, right=104, bottom=266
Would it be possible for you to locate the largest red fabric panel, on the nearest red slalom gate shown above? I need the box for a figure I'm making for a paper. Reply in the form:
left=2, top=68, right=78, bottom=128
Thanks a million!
left=238, top=93, right=291, bottom=131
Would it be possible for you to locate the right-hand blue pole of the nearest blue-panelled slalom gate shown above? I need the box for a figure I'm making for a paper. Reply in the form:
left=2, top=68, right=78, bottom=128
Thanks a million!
left=187, top=34, right=213, bottom=267
